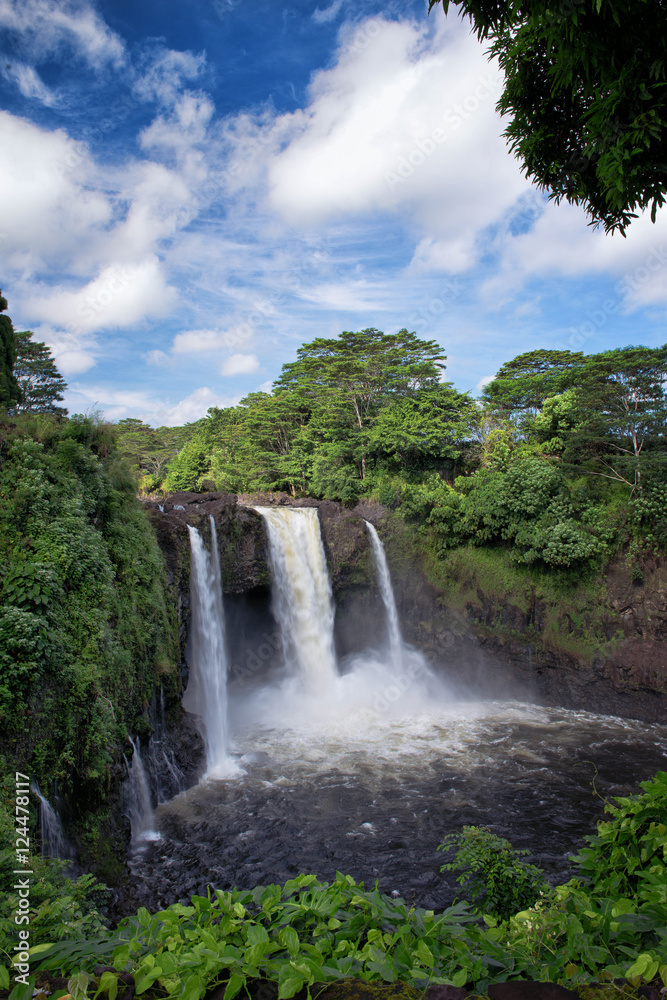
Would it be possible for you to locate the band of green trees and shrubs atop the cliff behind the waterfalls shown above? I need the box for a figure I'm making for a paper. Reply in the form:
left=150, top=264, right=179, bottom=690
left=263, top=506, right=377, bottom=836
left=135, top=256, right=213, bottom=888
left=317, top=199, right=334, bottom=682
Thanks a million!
left=137, top=330, right=667, bottom=577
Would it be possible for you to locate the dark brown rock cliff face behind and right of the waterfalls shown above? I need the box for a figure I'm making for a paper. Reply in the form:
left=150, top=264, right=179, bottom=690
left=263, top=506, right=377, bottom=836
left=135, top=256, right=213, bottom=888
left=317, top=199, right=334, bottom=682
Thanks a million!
left=146, top=493, right=667, bottom=722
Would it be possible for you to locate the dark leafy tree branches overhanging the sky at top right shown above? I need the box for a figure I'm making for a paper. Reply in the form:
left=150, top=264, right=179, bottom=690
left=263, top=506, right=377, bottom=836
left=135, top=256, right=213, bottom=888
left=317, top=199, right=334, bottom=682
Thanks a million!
left=429, top=0, right=667, bottom=234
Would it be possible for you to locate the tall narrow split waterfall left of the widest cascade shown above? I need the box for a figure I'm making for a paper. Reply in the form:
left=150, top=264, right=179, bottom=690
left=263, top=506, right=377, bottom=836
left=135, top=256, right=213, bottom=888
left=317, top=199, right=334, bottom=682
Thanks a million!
left=183, top=517, right=228, bottom=775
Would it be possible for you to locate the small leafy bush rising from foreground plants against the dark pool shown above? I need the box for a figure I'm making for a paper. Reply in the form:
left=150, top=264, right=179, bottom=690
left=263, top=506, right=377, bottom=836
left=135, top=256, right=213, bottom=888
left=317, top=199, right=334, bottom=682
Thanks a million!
left=438, top=826, right=549, bottom=920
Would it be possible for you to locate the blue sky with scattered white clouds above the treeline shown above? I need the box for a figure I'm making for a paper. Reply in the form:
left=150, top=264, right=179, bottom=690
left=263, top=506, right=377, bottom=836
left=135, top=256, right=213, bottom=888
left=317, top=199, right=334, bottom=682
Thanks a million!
left=0, top=0, right=667, bottom=425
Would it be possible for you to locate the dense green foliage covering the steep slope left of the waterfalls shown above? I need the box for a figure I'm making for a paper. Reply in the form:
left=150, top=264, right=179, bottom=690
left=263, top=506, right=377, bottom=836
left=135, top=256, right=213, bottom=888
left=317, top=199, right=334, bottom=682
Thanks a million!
left=0, top=414, right=177, bottom=815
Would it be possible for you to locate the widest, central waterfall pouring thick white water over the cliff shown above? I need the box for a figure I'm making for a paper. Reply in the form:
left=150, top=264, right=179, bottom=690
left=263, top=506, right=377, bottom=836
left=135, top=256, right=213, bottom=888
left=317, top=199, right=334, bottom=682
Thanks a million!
left=255, top=507, right=338, bottom=694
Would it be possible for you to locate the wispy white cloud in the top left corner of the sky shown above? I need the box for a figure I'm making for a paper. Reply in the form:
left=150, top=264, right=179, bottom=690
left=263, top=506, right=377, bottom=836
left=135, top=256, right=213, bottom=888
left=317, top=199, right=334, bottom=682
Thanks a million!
left=0, top=0, right=125, bottom=69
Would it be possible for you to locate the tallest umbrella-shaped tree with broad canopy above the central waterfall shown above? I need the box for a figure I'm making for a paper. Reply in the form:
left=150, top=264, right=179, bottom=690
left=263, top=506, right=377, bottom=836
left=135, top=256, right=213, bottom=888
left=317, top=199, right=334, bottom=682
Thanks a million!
left=275, top=328, right=446, bottom=479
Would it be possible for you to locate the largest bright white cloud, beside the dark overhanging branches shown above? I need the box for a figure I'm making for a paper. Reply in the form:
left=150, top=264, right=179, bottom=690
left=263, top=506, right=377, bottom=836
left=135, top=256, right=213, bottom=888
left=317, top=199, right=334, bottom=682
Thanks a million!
left=224, top=19, right=530, bottom=271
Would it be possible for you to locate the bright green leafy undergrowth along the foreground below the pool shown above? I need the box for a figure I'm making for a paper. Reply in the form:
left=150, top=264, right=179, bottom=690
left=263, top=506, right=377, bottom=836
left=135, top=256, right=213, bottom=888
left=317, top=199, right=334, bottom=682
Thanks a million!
left=0, top=772, right=667, bottom=1000
